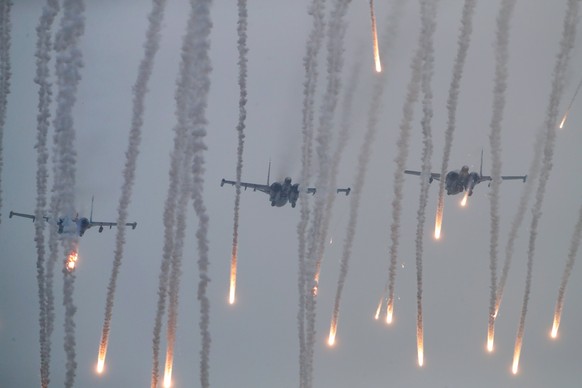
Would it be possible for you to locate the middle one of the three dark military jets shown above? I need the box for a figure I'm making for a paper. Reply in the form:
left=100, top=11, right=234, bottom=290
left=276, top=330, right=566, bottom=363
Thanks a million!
left=220, top=163, right=352, bottom=207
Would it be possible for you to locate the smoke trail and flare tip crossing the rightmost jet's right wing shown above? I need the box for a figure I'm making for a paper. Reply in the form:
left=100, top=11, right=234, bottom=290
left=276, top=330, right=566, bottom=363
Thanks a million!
left=487, top=0, right=516, bottom=351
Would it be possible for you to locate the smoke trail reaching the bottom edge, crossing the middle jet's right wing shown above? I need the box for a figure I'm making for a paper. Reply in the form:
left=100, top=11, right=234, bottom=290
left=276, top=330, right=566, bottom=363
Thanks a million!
left=297, top=0, right=325, bottom=387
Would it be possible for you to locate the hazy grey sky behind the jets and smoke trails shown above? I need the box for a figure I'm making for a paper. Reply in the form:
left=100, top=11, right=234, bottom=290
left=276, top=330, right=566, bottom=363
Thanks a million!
left=0, top=0, right=582, bottom=388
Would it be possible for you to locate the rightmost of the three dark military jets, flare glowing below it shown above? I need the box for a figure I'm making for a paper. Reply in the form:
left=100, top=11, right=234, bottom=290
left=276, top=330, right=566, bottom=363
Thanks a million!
left=404, top=151, right=527, bottom=196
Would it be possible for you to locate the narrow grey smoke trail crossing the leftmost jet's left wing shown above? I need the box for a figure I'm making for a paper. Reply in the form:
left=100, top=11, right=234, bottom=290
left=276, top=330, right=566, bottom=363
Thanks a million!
left=33, top=0, right=59, bottom=388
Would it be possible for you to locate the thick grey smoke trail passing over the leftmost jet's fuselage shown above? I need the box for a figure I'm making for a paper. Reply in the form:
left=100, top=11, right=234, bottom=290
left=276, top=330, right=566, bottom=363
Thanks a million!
left=52, top=0, right=85, bottom=387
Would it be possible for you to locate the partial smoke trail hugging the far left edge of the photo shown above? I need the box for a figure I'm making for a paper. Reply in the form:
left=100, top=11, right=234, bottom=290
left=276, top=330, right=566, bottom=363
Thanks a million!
left=0, top=0, right=12, bottom=223
